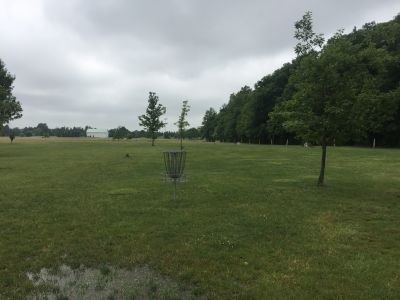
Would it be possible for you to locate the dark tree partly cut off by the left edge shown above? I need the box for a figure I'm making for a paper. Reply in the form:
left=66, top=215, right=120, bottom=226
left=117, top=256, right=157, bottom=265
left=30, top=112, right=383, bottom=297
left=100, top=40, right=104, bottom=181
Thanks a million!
left=0, top=59, right=22, bottom=129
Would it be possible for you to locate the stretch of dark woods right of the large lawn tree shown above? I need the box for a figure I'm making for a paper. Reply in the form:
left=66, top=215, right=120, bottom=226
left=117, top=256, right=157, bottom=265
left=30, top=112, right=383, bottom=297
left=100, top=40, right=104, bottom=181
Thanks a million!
left=345, top=16, right=400, bottom=146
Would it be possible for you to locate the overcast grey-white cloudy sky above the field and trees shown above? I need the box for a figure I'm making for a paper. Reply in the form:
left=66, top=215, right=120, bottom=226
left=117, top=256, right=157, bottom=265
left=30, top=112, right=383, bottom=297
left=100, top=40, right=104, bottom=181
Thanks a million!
left=0, top=0, right=400, bottom=129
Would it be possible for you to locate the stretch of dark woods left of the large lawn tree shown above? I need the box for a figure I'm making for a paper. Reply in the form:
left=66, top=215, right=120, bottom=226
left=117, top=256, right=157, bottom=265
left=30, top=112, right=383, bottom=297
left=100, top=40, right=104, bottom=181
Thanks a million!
left=203, top=63, right=295, bottom=143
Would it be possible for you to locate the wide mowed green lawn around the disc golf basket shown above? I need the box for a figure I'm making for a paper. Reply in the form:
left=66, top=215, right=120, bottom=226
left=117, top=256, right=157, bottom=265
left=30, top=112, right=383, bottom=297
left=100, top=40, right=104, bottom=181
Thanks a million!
left=0, top=138, right=400, bottom=299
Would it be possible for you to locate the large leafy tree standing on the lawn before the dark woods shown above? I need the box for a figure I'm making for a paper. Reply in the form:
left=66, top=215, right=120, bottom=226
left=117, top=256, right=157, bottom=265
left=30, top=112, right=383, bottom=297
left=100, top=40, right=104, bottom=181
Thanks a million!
left=269, top=12, right=365, bottom=185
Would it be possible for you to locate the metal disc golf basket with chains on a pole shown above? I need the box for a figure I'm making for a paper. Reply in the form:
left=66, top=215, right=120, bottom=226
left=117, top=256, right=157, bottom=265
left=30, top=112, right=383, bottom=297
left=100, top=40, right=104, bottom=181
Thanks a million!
left=163, top=150, right=186, bottom=200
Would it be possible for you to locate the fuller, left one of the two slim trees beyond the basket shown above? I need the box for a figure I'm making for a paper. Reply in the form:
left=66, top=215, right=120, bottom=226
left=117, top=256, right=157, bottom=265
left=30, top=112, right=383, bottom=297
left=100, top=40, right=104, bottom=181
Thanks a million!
left=139, top=92, right=167, bottom=146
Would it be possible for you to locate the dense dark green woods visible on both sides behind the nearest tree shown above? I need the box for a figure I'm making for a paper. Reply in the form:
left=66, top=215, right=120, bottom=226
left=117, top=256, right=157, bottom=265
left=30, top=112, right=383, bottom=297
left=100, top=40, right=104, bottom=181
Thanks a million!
left=202, top=15, right=400, bottom=146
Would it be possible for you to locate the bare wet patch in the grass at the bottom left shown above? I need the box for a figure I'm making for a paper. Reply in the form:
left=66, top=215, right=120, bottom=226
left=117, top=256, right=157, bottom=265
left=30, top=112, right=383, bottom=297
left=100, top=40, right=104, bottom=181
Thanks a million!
left=27, top=265, right=203, bottom=300
